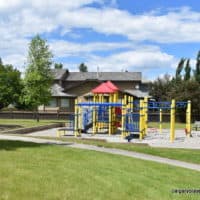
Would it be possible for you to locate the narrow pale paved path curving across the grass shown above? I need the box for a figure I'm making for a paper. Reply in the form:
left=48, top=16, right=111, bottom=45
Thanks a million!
left=0, top=134, right=200, bottom=171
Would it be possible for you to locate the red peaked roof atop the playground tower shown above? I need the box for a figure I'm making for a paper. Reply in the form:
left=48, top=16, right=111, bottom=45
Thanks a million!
left=92, top=81, right=119, bottom=94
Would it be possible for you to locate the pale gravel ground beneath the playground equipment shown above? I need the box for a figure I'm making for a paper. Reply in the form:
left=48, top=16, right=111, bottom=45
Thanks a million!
left=27, top=128, right=200, bottom=149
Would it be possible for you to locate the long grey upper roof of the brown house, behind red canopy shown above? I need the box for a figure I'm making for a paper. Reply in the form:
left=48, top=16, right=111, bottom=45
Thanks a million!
left=66, top=72, right=142, bottom=81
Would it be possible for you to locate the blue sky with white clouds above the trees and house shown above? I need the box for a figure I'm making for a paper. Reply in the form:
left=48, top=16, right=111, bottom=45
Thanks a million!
left=0, top=0, right=200, bottom=80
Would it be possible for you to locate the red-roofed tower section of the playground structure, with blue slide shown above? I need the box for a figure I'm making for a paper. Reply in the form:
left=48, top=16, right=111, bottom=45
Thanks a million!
left=74, top=81, right=121, bottom=136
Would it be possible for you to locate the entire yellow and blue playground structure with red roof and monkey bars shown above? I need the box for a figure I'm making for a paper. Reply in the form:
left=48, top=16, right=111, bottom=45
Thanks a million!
left=57, top=81, right=191, bottom=142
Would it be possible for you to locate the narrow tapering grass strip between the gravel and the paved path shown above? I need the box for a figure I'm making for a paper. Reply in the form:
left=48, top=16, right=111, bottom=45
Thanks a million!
left=40, top=137, right=200, bottom=164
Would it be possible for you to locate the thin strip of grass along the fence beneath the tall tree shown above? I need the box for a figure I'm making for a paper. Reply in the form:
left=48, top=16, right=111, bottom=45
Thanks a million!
left=0, top=119, right=65, bottom=128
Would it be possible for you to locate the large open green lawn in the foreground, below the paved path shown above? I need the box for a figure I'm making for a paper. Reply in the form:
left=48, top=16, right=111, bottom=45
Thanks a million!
left=0, top=140, right=200, bottom=200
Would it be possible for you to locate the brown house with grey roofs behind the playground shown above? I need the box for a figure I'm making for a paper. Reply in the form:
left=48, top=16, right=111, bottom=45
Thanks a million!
left=49, top=69, right=148, bottom=112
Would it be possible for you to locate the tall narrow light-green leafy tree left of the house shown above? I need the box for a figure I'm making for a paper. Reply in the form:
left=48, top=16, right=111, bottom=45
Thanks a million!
left=24, top=35, right=53, bottom=120
